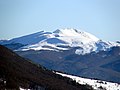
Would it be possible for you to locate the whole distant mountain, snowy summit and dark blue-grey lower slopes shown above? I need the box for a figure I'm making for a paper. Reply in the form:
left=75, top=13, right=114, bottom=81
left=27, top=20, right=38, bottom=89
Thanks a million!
left=0, top=28, right=120, bottom=83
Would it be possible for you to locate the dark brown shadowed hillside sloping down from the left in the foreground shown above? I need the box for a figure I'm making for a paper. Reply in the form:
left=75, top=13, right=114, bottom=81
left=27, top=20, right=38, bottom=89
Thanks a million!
left=0, top=45, right=92, bottom=90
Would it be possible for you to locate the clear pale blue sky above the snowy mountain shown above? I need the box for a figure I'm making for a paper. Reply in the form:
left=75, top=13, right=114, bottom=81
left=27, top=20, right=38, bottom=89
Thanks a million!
left=0, top=0, right=120, bottom=41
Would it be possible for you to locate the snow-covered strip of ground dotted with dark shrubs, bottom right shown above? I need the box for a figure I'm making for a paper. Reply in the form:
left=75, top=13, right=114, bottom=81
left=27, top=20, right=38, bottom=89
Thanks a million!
left=55, top=72, right=120, bottom=90
